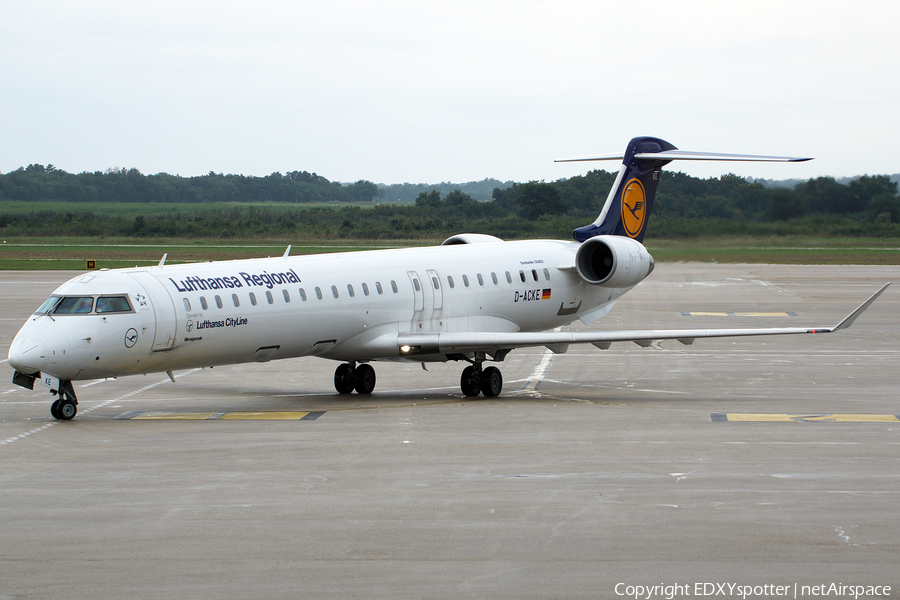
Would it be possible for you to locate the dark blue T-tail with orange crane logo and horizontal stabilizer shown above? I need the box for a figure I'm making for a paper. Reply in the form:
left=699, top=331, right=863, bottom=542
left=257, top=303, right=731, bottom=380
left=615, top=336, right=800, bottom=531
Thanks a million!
left=556, top=137, right=811, bottom=242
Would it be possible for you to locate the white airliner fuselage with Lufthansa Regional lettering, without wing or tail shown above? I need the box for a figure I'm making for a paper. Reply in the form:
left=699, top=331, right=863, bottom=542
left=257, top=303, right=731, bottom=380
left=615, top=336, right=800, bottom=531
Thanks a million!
left=10, top=240, right=633, bottom=380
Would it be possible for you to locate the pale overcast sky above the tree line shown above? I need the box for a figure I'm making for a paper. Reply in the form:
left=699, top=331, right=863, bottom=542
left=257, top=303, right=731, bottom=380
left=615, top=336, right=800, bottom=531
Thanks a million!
left=0, top=0, right=900, bottom=183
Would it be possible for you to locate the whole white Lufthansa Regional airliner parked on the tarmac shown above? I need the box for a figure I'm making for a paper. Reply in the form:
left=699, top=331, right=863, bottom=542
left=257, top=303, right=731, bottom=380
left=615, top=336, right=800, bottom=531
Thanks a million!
left=9, top=137, right=890, bottom=420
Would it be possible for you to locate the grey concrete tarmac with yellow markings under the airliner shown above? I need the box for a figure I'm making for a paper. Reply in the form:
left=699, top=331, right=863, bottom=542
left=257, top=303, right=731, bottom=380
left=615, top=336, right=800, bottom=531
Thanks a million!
left=0, top=264, right=900, bottom=600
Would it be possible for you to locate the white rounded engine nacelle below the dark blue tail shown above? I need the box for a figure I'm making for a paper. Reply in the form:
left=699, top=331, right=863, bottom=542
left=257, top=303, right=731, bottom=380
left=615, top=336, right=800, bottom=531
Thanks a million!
left=575, top=235, right=654, bottom=288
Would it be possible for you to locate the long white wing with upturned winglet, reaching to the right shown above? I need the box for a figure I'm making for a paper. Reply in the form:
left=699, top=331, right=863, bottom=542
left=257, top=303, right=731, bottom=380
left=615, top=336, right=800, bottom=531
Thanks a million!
left=397, top=283, right=891, bottom=356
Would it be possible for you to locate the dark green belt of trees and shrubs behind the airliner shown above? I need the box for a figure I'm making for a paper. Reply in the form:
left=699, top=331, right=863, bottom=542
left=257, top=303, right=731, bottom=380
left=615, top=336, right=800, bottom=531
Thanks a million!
left=0, top=165, right=900, bottom=239
